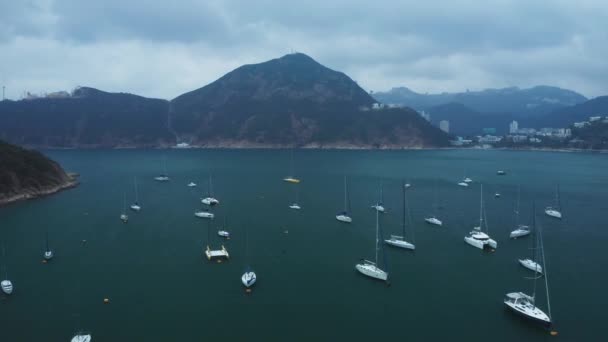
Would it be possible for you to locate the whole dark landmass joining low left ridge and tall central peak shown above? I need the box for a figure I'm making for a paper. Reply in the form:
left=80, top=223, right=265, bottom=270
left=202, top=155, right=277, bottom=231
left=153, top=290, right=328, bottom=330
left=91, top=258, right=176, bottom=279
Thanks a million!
left=0, top=54, right=448, bottom=148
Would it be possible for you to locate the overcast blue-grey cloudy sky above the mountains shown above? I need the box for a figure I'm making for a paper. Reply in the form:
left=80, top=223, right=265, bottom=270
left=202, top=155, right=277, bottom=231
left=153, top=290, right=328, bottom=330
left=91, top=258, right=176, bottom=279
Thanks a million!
left=0, top=0, right=608, bottom=99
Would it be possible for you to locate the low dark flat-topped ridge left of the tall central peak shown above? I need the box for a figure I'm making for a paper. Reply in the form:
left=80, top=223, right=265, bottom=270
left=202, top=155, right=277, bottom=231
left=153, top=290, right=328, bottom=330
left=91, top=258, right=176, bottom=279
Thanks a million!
left=0, top=87, right=174, bottom=147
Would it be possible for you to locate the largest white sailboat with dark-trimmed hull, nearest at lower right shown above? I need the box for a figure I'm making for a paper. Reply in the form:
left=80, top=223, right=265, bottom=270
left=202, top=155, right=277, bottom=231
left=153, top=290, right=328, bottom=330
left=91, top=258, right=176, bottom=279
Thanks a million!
left=504, top=204, right=552, bottom=327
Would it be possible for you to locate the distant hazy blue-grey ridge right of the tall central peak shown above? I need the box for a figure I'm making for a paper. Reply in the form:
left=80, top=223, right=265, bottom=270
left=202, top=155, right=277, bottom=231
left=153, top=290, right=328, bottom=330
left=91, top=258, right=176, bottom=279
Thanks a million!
left=374, top=86, right=587, bottom=115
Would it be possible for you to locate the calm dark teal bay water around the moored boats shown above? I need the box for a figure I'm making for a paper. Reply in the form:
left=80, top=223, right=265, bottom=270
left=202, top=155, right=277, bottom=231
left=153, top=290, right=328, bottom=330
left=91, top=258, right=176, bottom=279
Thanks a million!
left=0, top=150, right=608, bottom=341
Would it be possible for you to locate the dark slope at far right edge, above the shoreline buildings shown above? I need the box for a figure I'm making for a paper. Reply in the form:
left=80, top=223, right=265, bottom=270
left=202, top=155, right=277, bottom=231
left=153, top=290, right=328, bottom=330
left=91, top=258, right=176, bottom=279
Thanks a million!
left=534, top=96, right=608, bottom=127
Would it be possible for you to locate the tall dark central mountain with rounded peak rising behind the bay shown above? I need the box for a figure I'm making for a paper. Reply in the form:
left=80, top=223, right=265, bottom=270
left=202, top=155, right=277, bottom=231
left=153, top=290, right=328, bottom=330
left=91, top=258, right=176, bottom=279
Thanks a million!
left=170, top=53, right=448, bottom=147
